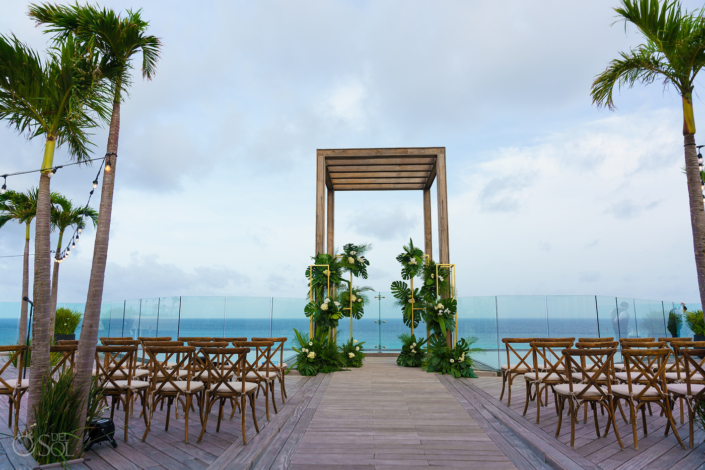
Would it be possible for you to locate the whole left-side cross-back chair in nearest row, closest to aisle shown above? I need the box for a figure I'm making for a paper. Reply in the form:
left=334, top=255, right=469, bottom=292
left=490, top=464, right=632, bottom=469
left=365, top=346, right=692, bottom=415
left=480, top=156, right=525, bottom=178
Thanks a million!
left=198, top=347, right=259, bottom=445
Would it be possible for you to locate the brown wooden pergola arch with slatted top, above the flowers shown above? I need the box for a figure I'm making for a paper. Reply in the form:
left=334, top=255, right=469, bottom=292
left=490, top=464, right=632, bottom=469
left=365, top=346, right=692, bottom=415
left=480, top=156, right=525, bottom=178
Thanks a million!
left=316, top=147, right=450, bottom=263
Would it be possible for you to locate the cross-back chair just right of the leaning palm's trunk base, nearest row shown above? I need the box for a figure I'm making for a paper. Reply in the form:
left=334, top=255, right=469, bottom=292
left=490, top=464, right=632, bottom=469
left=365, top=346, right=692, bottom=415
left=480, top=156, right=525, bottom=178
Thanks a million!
left=95, top=345, right=149, bottom=442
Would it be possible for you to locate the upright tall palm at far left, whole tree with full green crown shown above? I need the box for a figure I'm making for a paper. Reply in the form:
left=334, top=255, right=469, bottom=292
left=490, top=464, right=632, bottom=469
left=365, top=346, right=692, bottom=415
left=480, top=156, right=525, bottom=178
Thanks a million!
left=0, top=35, right=107, bottom=428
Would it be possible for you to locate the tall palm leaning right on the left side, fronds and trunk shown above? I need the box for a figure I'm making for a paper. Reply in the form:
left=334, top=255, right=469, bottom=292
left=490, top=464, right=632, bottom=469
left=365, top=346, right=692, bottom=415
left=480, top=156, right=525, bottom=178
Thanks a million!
left=29, top=4, right=161, bottom=434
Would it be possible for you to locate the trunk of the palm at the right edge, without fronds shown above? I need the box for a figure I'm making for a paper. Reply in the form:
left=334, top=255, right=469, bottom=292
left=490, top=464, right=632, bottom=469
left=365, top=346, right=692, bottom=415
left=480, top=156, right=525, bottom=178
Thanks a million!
left=683, top=93, right=705, bottom=305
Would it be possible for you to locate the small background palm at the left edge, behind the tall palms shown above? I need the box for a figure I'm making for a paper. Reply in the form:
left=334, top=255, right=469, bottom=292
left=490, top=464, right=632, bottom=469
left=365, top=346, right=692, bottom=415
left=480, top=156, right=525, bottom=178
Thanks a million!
left=0, top=188, right=38, bottom=344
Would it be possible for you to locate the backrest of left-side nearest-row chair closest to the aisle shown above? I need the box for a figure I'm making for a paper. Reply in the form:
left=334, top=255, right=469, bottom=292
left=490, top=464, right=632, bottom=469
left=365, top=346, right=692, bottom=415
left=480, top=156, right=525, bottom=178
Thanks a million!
left=201, top=347, right=256, bottom=395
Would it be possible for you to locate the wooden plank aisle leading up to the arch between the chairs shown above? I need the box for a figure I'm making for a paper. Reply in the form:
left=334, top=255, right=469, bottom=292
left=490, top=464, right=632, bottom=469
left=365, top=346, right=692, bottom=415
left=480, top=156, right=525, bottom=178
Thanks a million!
left=288, top=357, right=515, bottom=470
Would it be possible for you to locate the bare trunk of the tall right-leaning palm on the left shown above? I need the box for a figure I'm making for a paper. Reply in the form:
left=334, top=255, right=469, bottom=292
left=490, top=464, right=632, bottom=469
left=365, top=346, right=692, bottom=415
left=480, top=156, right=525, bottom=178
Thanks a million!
left=74, top=93, right=120, bottom=442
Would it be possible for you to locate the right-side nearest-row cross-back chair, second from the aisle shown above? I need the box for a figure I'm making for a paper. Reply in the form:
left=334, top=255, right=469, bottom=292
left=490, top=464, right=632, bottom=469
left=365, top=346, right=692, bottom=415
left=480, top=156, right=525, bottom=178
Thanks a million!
left=612, top=348, right=685, bottom=450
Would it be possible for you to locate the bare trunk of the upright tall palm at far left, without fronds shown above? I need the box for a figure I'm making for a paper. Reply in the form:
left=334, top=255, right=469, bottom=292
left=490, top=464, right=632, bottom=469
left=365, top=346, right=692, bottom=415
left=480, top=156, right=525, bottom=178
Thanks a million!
left=27, top=135, right=56, bottom=429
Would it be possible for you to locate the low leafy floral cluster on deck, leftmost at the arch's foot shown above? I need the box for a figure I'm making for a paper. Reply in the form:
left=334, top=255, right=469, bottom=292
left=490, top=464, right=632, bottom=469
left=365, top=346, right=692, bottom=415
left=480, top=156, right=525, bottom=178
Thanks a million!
left=291, top=329, right=345, bottom=376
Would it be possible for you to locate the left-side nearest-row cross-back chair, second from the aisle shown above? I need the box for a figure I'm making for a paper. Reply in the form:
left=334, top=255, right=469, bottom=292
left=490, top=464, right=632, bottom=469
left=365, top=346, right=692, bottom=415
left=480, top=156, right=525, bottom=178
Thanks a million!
left=142, top=342, right=205, bottom=444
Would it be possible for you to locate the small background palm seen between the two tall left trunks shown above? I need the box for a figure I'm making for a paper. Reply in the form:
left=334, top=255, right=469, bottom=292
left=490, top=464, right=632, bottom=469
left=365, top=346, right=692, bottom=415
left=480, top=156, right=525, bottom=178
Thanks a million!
left=49, top=194, right=98, bottom=333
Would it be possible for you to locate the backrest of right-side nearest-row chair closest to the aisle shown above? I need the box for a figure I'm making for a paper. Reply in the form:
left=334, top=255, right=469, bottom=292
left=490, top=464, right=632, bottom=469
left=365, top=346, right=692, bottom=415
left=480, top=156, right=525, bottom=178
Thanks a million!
left=561, top=342, right=617, bottom=400
